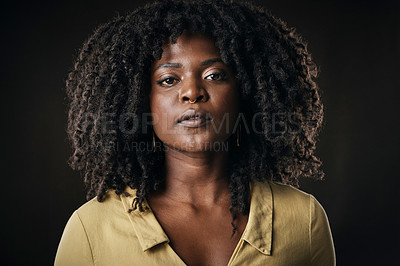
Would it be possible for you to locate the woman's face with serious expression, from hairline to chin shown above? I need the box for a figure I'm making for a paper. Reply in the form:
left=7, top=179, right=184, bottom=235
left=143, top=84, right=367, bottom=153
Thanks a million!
left=150, top=32, right=239, bottom=152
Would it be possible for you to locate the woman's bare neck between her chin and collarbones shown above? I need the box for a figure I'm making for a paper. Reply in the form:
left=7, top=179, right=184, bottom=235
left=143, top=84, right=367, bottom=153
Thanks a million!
left=162, top=145, right=230, bottom=206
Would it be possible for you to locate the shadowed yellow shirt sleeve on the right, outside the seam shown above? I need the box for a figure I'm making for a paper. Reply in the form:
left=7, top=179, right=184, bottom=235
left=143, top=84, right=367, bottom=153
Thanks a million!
left=310, top=196, right=336, bottom=266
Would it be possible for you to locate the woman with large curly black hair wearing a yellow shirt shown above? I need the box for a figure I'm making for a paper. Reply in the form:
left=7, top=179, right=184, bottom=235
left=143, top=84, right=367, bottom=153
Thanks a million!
left=55, top=1, right=335, bottom=265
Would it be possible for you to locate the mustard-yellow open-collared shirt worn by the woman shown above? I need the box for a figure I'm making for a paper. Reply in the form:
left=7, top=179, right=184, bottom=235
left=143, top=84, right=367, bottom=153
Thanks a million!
left=55, top=182, right=335, bottom=266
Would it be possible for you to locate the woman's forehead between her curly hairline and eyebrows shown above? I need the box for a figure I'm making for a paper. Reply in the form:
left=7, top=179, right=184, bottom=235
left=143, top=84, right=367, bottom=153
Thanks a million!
left=160, top=32, right=220, bottom=61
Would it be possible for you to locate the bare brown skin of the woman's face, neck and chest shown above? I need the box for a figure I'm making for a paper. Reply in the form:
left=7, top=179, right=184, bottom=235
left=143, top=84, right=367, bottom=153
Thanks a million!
left=147, top=32, right=248, bottom=265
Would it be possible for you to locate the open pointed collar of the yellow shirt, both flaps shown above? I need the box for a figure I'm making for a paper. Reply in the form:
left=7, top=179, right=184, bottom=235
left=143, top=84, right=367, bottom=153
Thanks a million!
left=120, top=182, right=273, bottom=255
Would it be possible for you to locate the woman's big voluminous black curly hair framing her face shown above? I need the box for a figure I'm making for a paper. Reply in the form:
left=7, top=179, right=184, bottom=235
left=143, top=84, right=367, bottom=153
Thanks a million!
left=66, top=0, right=323, bottom=231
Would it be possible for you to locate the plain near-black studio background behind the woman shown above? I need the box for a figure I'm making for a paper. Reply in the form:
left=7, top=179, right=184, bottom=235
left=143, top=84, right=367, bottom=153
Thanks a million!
left=0, top=0, right=400, bottom=265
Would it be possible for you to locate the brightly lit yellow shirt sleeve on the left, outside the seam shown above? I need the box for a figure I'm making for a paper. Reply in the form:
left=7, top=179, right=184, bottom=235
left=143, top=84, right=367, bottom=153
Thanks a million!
left=54, top=211, right=94, bottom=266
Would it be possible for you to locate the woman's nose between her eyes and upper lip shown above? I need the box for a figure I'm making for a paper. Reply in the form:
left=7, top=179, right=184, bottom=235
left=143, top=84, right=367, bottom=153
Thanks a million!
left=179, top=79, right=209, bottom=103
